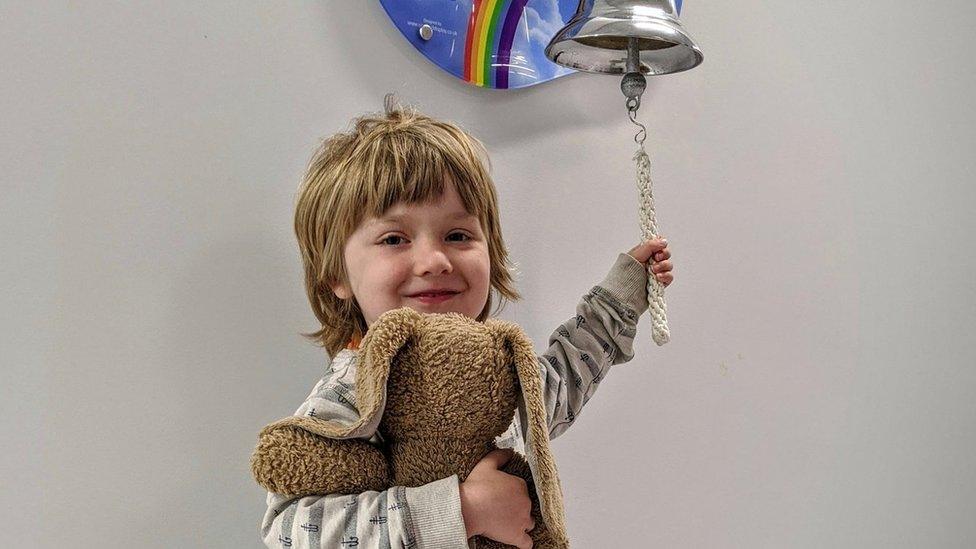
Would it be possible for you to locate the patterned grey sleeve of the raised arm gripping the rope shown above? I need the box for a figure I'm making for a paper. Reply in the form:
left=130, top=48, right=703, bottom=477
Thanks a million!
left=536, top=253, right=647, bottom=439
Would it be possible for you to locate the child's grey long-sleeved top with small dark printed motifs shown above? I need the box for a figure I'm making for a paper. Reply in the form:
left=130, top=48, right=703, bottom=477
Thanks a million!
left=261, top=253, right=647, bottom=549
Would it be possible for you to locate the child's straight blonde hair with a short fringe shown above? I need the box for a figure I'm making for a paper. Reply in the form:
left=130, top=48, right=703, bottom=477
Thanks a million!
left=295, top=96, right=521, bottom=356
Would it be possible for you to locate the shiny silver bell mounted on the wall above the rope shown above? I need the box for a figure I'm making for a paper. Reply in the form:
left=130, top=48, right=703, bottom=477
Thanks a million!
left=546, top=0, right=704, bottom=75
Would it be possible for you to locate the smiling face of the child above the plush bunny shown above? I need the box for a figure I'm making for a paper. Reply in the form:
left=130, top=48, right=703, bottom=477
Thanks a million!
left=332, top=182, right=491, bottom=326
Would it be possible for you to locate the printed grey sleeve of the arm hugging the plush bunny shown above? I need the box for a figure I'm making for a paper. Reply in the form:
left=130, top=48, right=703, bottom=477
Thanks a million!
left=261, top=356, right=468, bottom=549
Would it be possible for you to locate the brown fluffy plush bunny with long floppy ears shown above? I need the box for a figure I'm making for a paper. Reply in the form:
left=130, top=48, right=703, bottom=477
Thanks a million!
left=251, top=307, right=569, bottom=549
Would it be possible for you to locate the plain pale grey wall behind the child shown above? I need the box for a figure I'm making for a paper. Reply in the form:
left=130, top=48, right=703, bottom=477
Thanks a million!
left=0, top=0, right=976, bottom=548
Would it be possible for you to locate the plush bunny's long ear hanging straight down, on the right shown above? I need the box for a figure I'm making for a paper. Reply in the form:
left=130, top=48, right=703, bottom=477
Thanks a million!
left=485, top=319, right=569, bottom=547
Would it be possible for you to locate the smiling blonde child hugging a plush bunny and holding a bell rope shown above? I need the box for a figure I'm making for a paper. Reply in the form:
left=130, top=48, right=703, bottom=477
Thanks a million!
left=262, top=101, right=673, bottom=549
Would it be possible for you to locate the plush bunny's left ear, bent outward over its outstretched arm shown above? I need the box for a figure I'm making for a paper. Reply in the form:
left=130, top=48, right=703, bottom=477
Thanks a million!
left=255, top=307, right=420, bottom=439
